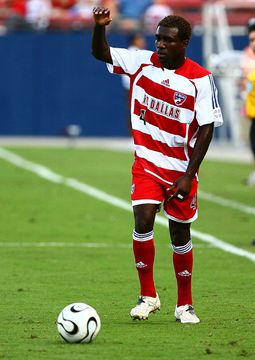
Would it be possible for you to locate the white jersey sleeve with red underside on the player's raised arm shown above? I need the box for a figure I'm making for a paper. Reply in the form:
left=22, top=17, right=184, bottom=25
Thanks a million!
left=107, top=47, right=153, bottom=75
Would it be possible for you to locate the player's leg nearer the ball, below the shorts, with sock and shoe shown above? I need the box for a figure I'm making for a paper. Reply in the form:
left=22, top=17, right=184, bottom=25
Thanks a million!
left=130, top=204, right=160, bottom=320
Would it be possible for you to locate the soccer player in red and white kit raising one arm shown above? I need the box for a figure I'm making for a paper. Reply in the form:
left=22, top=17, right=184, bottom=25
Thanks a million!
left=92, top=7, right=223, bottom=324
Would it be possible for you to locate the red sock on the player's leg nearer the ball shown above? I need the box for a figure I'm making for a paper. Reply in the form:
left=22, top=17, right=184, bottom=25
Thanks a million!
left=133, top=231, right=156, bottom=297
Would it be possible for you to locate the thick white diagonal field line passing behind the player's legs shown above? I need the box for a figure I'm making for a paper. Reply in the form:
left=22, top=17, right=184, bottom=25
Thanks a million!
left=0, top=148, right=255, bottom=262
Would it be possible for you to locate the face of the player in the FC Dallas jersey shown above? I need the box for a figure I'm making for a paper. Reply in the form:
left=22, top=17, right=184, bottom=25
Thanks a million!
left=155, top=26, right=188, bottom=69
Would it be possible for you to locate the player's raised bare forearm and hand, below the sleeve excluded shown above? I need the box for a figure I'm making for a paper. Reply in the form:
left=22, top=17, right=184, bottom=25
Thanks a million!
left=92, top=7, right=112, bottom=64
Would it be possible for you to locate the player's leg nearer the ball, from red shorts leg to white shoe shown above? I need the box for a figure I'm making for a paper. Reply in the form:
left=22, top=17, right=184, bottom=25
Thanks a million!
left=130, top=162, right=164, bottom=320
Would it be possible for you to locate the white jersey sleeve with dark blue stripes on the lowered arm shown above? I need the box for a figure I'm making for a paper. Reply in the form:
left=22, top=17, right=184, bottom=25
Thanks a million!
left=193, top=74, right=223, bottom=127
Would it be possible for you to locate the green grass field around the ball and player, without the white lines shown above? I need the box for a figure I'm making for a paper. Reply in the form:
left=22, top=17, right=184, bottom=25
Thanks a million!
left=0, top=147, right=255, bottom=360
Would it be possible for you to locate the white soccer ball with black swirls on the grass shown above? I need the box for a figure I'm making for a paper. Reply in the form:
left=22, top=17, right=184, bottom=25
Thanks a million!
left=57, top=303, right=101, bottom=343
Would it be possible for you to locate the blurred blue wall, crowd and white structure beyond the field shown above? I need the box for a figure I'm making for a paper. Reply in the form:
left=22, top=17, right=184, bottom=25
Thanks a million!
left=0, top=0, right=255, bottom=153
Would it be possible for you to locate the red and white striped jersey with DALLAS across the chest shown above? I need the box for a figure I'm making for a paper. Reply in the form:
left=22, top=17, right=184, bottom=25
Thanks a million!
left=107, top=48, right=223, bottom=183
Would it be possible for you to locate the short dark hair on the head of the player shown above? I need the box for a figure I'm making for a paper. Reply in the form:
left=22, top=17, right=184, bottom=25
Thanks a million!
left=158, top=15, right=192, bottom=40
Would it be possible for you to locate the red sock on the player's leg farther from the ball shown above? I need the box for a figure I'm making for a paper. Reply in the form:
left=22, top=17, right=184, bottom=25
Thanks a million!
left=173, top=244, right=193, bottom=306
